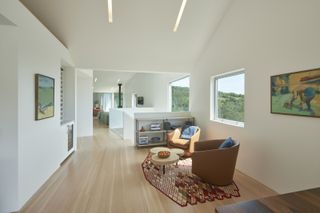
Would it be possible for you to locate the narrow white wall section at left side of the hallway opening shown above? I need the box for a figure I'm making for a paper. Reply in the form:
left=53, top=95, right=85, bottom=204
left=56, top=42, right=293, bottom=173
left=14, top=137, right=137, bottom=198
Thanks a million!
left=77, top=70, right=93, bottom=137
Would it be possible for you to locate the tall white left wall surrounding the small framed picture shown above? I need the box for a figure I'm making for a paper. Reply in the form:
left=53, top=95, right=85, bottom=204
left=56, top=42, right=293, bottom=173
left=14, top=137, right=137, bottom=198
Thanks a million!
left=18, top=14, right=74, bottom=211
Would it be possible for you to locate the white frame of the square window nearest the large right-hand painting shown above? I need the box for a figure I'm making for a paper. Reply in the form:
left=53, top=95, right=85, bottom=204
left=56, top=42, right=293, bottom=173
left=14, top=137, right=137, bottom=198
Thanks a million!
left=210, top=68, right=246, bottom=128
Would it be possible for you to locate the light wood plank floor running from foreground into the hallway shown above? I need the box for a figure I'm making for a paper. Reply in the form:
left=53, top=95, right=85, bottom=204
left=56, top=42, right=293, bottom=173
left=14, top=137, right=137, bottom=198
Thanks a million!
left=20, top=123, right=275, bottom=213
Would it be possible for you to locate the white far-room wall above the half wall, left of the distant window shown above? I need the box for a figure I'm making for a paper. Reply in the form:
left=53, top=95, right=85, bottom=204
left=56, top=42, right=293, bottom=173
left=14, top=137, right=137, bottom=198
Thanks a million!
left=124, top=73, right=187, bottom=111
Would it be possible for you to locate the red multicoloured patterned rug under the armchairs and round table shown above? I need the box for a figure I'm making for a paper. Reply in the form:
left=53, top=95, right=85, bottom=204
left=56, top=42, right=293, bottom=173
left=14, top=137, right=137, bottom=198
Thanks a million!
left=142, top=154, right=240, bottom=206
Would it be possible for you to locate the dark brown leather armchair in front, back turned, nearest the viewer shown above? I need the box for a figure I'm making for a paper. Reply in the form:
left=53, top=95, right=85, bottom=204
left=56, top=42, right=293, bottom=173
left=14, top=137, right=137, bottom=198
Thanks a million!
left=192, top=139, right=240, bottom=186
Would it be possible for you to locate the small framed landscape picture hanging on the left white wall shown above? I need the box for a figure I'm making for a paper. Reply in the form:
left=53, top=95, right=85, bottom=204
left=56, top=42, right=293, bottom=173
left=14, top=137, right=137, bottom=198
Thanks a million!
left=35, top=74, right=54, bottom=120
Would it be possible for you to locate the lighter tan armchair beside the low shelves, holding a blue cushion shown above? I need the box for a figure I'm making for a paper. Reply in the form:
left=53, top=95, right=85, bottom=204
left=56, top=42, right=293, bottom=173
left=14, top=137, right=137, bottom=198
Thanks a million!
left=167, top=127, right=201, bottom=157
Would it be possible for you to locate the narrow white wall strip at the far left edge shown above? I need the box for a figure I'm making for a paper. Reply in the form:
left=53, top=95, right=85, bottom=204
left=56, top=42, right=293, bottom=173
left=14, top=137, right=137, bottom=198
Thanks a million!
left=0, top=25, right=18, bottom=213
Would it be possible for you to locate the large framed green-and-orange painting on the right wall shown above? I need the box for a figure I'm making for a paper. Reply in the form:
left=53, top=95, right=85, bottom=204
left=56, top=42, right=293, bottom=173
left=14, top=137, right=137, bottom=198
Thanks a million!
left=271, top=68, right=320, bottom=117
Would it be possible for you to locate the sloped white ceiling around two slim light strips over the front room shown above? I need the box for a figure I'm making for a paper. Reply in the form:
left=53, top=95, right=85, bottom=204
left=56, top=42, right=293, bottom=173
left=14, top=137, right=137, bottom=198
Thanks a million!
left=21, top=0, right=232, bottom=73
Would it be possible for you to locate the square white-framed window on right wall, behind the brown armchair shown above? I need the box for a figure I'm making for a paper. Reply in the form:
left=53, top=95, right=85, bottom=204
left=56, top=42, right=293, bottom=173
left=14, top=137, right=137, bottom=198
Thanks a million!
left=210, top=69, right=245, bottom=127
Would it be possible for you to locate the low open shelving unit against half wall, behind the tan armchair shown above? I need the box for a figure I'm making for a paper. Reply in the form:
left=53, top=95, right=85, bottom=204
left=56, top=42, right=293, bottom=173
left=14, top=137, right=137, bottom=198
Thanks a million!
left=135, top=117, right=194, bottom=147
